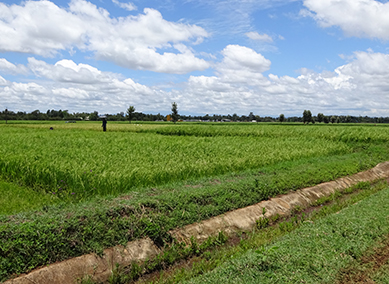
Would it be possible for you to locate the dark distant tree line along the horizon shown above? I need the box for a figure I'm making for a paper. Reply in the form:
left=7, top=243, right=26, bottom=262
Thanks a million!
left=0, top=106, right=389, bottom=124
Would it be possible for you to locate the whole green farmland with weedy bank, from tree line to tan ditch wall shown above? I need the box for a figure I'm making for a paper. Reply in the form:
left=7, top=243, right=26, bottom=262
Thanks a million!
left=0, top=122, right=389, bottom=281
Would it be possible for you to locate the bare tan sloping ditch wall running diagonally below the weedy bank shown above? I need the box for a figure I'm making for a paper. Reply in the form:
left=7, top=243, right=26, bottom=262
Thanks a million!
left=4, top=162, right=389, bottom=284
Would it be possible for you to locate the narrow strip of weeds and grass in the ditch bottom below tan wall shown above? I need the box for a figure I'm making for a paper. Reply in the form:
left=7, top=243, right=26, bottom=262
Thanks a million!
left=80, top=182, right=387, bottom=284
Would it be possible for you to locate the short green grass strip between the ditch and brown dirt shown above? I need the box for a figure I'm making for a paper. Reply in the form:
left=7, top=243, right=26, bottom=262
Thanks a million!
left=183, top=184, right=389, bottom=283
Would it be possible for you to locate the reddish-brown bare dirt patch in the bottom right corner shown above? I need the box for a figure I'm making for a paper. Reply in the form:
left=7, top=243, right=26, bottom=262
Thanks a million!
left=336, top=236, right=389, bottom=284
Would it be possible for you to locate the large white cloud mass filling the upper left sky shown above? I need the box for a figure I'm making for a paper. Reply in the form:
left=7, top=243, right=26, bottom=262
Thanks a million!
left=0, top=0, right=209, bottom=74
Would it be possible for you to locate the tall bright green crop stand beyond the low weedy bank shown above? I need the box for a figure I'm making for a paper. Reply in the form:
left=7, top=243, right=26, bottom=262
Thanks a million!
left=0, top=125, right=354, bottom=199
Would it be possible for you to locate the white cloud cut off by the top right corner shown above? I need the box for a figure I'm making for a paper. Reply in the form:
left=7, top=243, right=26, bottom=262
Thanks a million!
left=300, top=0, right=389, bottom=40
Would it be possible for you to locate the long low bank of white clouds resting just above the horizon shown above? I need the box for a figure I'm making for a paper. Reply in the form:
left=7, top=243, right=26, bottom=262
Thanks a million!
left=0, top=45, right=389, bottom=116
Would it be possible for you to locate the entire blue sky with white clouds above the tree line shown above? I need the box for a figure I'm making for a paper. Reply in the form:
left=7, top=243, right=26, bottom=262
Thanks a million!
left=0, top=0, right=389, bottom=117
